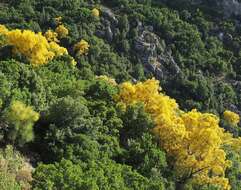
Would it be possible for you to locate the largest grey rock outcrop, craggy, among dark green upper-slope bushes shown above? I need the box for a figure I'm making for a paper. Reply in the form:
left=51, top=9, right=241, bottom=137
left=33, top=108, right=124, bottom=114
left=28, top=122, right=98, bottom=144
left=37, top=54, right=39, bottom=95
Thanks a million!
left=135, top=22, right=181, bottom=80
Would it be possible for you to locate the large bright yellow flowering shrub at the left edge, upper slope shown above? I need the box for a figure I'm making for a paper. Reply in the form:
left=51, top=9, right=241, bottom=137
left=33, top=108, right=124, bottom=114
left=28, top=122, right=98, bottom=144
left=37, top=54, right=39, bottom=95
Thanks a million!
left=0, top=24, right=68, bottom=66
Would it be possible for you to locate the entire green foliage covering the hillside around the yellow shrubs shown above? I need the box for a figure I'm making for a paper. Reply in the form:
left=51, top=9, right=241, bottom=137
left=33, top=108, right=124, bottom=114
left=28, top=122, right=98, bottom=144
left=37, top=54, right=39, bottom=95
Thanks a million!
left=0, top=0, right=241, bottom=190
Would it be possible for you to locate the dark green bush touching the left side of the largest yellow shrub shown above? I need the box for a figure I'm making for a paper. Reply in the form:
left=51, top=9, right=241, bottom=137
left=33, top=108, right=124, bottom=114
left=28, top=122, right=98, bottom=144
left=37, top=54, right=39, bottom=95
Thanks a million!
left=117, top=105, right=167, bottom=178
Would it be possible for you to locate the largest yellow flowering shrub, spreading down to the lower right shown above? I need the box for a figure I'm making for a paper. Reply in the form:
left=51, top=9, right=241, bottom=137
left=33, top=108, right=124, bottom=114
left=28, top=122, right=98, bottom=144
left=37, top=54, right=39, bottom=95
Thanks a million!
left=115, top=79, right=241, bottom=190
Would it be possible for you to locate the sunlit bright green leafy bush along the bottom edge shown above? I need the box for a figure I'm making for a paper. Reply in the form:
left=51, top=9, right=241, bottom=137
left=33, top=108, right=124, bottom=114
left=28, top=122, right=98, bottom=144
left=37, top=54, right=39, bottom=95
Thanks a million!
left=33, top=160, right=166, bottom=190
